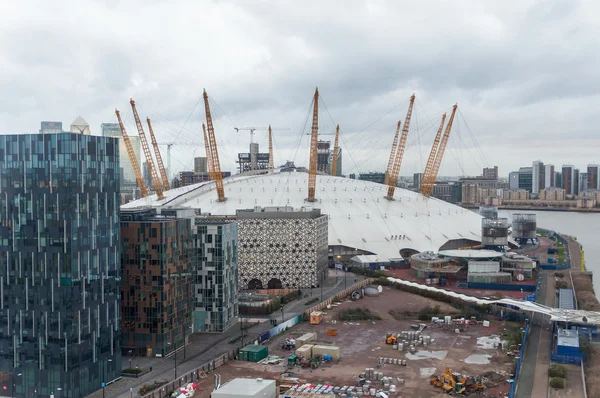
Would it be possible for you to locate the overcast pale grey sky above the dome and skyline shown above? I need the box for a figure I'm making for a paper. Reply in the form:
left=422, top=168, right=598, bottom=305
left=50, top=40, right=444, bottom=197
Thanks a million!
left=0, top=0, right=600, bottom=176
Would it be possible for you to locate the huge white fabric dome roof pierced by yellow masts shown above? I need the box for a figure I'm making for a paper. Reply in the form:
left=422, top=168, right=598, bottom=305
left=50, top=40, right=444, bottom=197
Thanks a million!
left=122, top=169, right=481, bottom=259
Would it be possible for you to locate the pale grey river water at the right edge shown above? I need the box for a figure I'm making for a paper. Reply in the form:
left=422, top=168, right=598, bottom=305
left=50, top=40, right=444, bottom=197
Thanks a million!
left=498, top=210, right=600, bottom=296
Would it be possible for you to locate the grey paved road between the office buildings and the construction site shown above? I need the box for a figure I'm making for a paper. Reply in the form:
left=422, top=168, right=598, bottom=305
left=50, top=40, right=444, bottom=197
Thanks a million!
left=88, top=270, right=365, bottom=398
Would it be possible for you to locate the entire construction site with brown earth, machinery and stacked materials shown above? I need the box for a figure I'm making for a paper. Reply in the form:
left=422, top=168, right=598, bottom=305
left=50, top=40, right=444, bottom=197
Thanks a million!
left=196, top=287, right=523, bottom=398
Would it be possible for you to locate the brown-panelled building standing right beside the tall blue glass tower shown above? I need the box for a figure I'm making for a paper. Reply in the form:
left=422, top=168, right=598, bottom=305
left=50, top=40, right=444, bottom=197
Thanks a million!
left=121, top=209, right=194, bottom=357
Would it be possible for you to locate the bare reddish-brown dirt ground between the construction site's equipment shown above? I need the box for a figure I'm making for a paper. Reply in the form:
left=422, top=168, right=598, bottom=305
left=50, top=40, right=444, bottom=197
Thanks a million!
left=200, top=288, right=512, bottom=398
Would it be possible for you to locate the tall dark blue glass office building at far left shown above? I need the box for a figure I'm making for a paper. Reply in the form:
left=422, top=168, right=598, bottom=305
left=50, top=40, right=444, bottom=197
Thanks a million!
left=0, top=133, right=121, bottom=398
